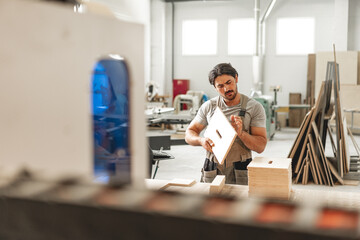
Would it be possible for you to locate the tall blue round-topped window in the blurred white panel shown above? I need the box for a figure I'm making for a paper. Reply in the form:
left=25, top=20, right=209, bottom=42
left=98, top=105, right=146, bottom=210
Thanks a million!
left=92, top=58, right=130, bottom=183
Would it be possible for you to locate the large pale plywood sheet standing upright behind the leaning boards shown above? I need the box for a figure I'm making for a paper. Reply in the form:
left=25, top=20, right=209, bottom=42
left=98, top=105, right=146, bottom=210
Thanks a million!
left=315, top=51, right=358, bottom=96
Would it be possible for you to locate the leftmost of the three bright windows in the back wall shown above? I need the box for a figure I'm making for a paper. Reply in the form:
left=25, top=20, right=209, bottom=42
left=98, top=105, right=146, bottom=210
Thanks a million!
left=182, top=20, right=217, bottom=55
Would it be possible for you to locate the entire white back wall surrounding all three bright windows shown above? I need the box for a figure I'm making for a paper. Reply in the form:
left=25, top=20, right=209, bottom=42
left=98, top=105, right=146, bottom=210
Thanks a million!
left=165, top=0, right=348, bottom=104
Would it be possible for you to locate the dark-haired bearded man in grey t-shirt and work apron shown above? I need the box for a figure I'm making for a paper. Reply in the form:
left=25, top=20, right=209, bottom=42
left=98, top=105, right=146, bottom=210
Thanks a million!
left=185, top=63, right=267, bottom=185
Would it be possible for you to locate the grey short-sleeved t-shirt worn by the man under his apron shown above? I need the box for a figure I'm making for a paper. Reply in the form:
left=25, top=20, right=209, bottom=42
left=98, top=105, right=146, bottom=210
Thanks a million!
left=194, top=96, right=266, bottom=132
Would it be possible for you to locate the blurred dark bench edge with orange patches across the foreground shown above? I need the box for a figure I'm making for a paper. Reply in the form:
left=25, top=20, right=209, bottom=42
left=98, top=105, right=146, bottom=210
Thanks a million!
left=0, top=176, right=360, bottom=240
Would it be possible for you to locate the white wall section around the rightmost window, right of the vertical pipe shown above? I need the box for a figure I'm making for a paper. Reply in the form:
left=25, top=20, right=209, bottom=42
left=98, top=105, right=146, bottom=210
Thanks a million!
left=263, top=0, right=334, bottom=104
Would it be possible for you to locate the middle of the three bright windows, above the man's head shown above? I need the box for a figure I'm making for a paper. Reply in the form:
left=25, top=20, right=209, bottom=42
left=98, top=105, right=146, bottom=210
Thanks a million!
left=228, top=18, right=255, bottom=55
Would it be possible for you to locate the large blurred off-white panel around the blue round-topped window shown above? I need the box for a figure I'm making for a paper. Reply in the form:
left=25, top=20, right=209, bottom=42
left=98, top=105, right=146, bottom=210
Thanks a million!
left=0, top=0, right=147, bottom=183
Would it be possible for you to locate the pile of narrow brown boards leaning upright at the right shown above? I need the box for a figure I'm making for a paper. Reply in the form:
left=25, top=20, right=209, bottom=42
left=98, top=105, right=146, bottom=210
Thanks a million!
left=288, top=57, right=351, bottom=186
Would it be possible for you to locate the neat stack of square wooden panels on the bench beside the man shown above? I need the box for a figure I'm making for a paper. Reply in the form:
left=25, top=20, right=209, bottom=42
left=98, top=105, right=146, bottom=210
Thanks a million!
left=248, top=157, right=292, bottom=199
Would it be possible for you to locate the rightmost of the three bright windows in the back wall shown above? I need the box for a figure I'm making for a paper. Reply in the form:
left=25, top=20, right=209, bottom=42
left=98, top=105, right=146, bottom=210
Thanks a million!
left=276, top=18, right=315, bottom=55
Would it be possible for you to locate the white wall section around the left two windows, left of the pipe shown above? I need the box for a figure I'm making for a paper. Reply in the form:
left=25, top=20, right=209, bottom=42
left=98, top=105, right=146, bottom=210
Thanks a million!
left=174, top=1, right=254, bottom=103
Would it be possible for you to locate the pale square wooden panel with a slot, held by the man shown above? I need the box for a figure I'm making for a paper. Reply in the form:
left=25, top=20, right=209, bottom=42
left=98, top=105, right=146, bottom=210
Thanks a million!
left=204, top=107, right=237, bottom=164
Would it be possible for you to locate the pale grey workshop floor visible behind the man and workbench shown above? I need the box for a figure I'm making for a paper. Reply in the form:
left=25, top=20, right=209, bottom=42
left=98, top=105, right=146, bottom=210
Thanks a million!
left=153, top=128, right=360, bottom=192
